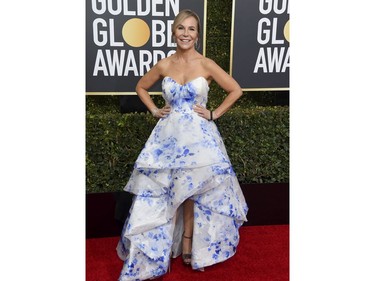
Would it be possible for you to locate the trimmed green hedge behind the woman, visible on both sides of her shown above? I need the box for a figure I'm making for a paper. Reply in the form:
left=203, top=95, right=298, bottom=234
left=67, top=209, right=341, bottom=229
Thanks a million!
left=86, top=106, right=289, bottom=193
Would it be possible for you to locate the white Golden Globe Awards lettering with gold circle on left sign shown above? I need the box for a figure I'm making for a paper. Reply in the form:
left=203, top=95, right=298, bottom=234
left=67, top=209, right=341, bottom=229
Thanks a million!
left=89, top=0, right=180, bottom=77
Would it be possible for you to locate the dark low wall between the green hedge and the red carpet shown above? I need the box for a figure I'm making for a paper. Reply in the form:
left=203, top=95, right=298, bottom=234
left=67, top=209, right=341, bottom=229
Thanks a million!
left=86, top=184, right=289, bottom=238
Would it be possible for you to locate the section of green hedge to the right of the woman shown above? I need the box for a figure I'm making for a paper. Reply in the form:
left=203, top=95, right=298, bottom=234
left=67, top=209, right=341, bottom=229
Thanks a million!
left=217, top=107, right=289, bottom=183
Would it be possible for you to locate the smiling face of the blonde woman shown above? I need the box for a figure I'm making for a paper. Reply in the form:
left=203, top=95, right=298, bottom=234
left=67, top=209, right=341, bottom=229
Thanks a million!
left=174, top=17, right=198, bottom=50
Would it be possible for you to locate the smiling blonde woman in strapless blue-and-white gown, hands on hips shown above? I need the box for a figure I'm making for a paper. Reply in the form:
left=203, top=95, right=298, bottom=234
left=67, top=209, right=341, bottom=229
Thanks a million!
left=117, top=10, right=248, bottom=281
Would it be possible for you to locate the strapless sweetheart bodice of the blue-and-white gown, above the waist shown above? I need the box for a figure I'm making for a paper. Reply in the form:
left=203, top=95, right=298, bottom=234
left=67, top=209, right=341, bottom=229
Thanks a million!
left=162, top=76, right=209, bottom=111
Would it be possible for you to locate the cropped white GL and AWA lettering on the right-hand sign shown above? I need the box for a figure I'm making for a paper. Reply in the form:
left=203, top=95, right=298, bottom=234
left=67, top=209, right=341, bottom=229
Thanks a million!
left=253, top=0, right=289, bottom=73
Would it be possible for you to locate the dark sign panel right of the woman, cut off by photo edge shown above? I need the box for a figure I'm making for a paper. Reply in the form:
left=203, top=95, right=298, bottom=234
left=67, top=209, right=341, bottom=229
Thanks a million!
left=230, top=0, right=290, bottom=91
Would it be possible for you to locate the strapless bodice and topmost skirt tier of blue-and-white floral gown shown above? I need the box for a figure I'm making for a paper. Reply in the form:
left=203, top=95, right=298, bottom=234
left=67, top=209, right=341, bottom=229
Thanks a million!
left=135, top=76, right=225, bottom=169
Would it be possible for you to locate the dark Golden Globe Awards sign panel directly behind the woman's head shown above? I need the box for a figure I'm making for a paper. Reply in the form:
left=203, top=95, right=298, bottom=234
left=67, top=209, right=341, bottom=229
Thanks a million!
left=86, top=0, right=206, bottom=95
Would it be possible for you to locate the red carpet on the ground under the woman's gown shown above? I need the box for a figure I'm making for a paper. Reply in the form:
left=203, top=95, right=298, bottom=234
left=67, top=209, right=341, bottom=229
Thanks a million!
left=86, top=225, right=289, bottom=281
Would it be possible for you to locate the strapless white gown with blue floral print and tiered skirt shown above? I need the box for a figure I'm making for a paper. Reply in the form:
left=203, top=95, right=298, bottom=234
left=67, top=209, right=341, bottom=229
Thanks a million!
left=117, top=77, right=248, bottom=281
